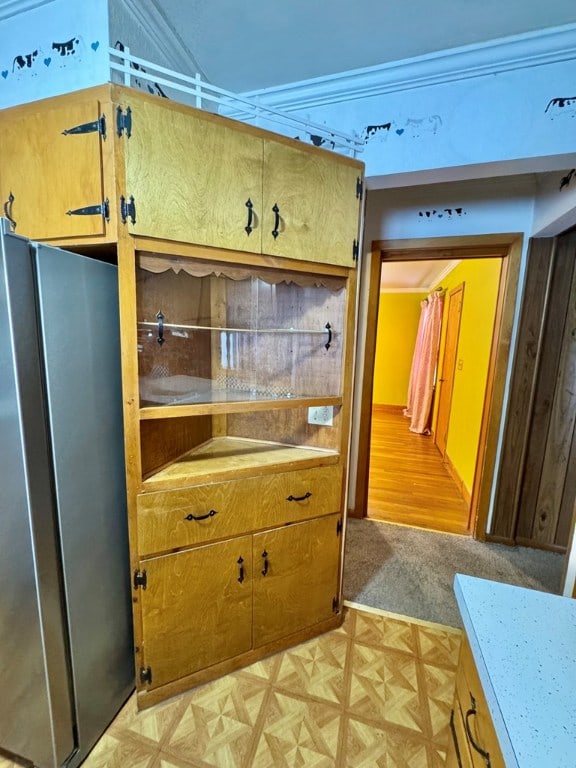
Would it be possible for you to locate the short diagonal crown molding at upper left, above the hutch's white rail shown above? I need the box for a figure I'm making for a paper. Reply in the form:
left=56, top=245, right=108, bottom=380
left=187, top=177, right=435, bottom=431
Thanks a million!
left=120, top=0, right=207, bottom=80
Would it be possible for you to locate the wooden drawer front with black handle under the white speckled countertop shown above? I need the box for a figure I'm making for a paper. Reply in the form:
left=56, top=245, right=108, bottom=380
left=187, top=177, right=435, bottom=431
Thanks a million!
left=456, top=637, right=506, bottom=768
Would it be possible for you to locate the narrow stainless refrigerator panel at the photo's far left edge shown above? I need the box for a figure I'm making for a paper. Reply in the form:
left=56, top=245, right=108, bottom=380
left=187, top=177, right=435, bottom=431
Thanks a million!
left=0, top=222, right=75, bottom=768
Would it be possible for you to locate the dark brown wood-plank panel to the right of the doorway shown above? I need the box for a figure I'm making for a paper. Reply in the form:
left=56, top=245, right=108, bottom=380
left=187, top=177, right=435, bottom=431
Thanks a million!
left=490, top=231, right=576, bottom=552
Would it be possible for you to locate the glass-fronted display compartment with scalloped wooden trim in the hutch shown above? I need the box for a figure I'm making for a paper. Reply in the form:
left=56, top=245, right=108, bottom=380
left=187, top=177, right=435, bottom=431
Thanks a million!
left=137, top=256, right=346, bottom=409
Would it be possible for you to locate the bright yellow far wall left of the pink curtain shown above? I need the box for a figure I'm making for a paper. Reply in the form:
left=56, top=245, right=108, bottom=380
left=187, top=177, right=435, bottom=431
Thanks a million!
left=372, top=293, right=425, bottom=406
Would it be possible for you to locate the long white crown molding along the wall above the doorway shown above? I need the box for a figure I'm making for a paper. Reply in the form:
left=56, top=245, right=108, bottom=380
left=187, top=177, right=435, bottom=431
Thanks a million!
left=241, top=24, right=576, bottom=111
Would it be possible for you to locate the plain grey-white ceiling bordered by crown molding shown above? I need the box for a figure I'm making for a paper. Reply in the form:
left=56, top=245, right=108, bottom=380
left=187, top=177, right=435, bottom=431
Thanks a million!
left=154, top=0, right=576, bottom=93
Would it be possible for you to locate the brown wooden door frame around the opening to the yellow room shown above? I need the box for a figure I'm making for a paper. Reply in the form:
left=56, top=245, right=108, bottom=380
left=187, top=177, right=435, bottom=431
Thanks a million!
left=350, top=236, right=521, bottom=539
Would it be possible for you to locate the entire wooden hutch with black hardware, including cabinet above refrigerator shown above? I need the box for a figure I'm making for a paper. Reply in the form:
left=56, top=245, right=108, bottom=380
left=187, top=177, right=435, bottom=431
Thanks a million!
left=0, top=85, right=363, bottom=707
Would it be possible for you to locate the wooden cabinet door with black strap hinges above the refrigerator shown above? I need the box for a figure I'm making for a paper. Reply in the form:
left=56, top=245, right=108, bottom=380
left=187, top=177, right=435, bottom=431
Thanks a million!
left=0, top=100, right=109, bottom=240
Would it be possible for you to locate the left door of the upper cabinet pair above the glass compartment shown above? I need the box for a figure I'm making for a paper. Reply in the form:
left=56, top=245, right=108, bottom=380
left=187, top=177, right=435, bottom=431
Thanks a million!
left=126, top=100, right=263, bottom=253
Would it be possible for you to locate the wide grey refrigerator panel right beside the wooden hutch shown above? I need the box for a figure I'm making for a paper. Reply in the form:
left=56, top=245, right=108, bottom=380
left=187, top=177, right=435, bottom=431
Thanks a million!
left=36, top=245, right=134, bottom=766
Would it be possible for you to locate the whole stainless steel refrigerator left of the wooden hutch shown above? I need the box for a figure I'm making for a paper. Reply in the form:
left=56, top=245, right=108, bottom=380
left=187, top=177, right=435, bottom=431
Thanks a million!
left=0, top=219, right=134, bottom=768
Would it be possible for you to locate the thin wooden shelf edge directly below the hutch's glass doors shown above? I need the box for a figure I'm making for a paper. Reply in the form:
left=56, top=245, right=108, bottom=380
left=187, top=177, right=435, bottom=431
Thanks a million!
left=140, top=397, right=342, bottom=419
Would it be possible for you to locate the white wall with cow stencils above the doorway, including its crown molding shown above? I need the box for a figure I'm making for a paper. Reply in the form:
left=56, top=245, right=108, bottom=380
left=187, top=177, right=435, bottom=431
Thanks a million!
left=242, top=25, right=576, bottom=188
